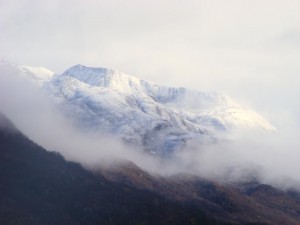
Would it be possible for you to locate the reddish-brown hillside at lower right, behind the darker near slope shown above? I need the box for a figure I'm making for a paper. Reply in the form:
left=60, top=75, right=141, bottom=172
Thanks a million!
left=99, top=163, right=300, bottom=224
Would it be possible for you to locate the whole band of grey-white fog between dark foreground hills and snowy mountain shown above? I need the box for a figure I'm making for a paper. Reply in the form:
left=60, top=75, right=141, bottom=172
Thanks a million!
left=0, top=60, right=300, bottom=191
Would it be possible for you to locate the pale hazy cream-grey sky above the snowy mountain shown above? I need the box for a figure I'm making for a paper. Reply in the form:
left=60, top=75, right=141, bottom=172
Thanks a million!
left=0, top=0, right=300, bottom=126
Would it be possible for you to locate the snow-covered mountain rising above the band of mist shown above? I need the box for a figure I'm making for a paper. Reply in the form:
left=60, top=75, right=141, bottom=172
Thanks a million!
left=1, top=60, right=275, bottom=157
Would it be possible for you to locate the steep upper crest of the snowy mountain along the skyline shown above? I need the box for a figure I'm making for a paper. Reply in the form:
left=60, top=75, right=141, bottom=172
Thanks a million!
left=62, top=65, right=237, bottom=109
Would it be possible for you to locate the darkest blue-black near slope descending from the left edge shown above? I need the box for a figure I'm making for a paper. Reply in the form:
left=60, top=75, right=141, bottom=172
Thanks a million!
left=0, top=112, right=223, bottom=225
